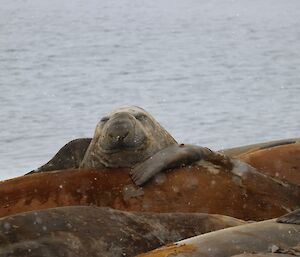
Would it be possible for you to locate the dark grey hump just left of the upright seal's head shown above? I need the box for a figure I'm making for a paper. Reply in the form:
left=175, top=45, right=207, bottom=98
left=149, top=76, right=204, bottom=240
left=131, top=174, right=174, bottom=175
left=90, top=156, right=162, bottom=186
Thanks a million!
left=25, top=138, right=92, bottom=175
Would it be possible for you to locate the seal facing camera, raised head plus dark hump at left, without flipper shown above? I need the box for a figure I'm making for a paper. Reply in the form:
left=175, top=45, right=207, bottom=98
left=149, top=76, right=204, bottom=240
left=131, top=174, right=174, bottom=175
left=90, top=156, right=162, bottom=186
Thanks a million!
left=27, top=106, right=177, bottom=174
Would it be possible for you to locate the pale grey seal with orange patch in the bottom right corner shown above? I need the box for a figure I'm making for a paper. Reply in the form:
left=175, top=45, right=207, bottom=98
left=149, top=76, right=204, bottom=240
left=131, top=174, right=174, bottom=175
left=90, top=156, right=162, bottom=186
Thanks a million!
left=138, top=209, right=300, bottom=257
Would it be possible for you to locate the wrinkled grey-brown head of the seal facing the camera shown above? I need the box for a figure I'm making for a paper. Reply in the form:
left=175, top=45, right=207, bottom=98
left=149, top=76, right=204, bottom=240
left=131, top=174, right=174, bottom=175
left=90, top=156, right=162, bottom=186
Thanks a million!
left=80, top=106, right=177, bottom=168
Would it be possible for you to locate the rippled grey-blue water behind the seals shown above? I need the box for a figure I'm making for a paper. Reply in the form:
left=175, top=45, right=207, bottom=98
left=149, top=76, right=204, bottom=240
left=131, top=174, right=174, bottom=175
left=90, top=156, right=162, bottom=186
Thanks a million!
left=0, top=0, right=300, bottom=179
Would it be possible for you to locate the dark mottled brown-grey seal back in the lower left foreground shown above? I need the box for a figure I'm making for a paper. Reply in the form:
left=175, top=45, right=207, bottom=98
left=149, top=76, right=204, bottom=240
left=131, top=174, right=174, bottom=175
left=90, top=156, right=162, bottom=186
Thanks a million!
left=0, top=206, right=245, bottom=257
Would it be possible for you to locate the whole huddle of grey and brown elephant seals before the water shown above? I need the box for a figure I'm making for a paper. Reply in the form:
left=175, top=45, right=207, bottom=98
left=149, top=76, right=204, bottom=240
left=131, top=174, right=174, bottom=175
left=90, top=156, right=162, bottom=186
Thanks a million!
left=0, top=106, right=300, bottom=257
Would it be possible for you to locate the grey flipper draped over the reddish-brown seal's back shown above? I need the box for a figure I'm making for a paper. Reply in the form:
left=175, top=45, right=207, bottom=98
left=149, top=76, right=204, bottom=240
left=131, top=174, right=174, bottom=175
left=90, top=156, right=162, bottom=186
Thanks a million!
left=130, top=144, right=214, bottom=186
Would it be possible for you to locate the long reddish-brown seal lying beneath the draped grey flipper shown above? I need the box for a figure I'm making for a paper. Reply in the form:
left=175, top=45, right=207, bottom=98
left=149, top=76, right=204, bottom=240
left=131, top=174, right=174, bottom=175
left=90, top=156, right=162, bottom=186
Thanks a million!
left=0, top=155, right=300, bottom=220
